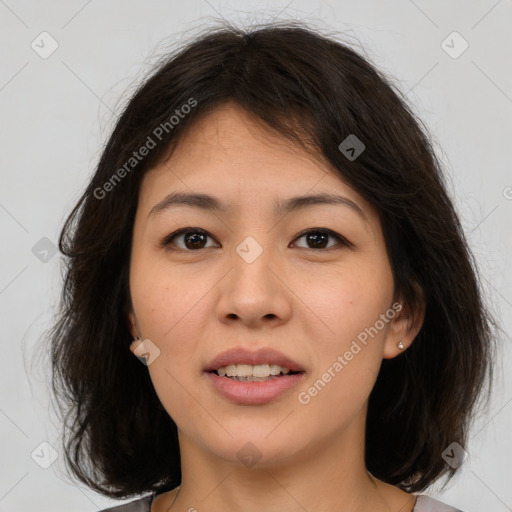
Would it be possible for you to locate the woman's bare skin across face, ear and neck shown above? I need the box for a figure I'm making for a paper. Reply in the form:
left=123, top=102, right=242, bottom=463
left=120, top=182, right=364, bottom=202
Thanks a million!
left=129, top=102, right=424, bottom=512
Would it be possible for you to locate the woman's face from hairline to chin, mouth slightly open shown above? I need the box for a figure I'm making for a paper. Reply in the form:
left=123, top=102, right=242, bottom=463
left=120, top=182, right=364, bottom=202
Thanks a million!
left=130, top=103, right=410, bottom=470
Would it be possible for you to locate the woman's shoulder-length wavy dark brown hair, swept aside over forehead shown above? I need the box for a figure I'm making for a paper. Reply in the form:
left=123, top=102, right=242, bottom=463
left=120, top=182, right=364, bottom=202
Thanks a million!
left=50, top=22, right=494, bottom=497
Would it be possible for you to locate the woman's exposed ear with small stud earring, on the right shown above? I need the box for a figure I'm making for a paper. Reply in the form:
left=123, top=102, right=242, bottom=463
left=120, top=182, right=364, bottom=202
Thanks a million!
left=382, top=283, right=426, bottom=359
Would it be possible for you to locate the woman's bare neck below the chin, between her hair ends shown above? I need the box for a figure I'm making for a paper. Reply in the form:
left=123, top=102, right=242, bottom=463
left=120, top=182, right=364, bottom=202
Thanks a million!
left=159, top=412, right=414, bottom=512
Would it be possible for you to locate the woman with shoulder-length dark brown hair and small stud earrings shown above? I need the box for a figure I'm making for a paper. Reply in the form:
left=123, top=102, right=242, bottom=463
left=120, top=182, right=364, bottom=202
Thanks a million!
left=52, top=22, right=493, bottom=512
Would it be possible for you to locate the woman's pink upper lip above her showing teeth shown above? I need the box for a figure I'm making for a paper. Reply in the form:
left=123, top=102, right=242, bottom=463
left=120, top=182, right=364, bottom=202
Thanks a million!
left=204, top=348, right=305, bottom=372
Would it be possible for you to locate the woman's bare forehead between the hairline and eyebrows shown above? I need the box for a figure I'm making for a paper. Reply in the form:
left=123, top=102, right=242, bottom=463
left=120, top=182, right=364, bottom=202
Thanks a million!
left=139, top=102, right=376, bottom=225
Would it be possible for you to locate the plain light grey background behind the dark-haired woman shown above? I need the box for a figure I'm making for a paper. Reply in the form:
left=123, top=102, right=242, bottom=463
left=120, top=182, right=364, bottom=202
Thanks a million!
left=0, top=0, right=512, bottom=512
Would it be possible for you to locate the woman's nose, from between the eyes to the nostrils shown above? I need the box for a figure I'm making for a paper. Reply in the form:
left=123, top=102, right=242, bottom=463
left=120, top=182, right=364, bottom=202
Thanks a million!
left=217, top=237, right=293, bottom=328
